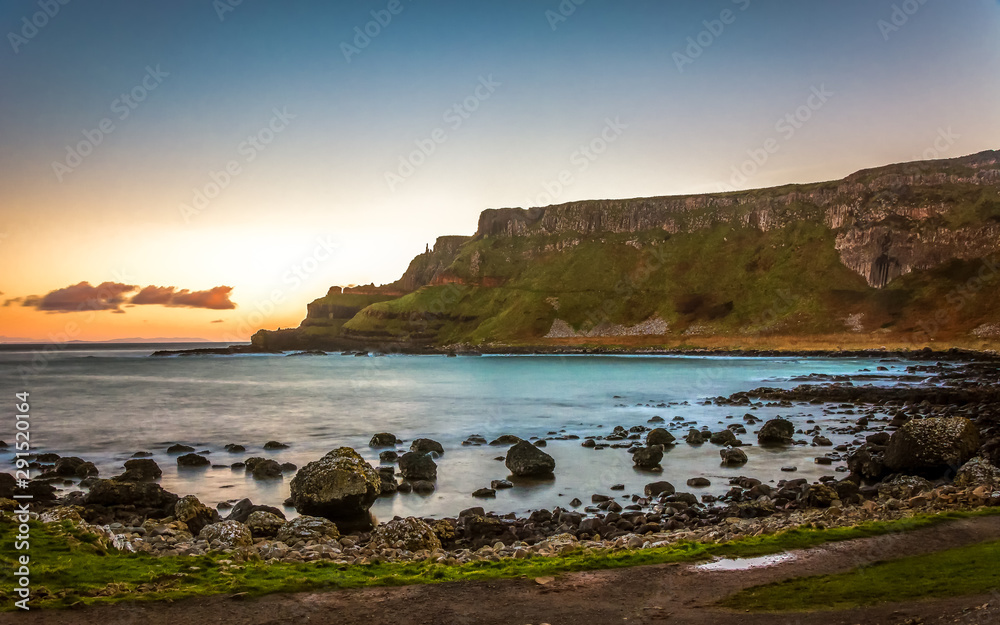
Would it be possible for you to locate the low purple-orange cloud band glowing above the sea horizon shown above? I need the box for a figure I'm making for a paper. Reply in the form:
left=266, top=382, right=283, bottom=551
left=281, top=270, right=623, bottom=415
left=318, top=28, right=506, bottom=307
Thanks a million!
left=19, top=282, right=236, bottom=314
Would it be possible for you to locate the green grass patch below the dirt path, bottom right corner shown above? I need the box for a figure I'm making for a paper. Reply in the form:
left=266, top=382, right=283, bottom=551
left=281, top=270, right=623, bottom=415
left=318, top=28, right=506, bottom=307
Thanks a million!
left=722, top=541, right=1000, bottom=612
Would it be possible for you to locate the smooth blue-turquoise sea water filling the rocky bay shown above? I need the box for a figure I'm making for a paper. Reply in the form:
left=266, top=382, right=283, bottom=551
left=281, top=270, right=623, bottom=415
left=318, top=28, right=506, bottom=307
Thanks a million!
left=0, top=344, right=919, bottom=520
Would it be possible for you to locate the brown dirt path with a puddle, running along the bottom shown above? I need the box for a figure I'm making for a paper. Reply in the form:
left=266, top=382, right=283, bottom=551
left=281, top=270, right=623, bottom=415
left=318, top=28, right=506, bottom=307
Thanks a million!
left=11, top=517, right=1000, bottom=625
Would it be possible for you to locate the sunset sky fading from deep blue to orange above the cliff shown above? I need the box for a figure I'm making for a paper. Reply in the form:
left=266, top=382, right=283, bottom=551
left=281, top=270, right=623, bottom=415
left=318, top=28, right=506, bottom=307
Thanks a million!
left=0, top=0, right=1000, bottom=341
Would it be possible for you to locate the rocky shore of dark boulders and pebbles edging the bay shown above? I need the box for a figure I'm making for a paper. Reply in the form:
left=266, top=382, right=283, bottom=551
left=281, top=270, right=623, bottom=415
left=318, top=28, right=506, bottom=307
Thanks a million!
left=0, top=354, right=1000, bottom=564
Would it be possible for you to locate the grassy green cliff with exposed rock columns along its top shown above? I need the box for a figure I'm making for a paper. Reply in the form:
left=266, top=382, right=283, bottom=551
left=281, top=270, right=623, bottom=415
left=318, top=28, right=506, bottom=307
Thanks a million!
left=255, top=151, right=1000, bottom=348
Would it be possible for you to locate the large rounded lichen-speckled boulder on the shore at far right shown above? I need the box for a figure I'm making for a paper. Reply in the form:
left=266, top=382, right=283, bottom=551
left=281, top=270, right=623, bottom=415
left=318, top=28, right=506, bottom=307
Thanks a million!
left=884, top=417, right=979, bottom=472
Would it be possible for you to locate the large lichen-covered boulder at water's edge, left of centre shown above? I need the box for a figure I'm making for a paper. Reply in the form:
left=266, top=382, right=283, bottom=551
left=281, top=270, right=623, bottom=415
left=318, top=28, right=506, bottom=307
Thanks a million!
left=290, top=447, right=382, bottom=521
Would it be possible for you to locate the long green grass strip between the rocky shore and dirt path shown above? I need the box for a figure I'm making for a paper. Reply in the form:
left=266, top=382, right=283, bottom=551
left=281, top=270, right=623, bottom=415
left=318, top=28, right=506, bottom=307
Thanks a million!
left=0, top=508, right=1000, bottom=609
